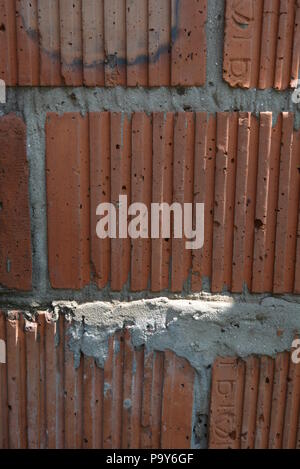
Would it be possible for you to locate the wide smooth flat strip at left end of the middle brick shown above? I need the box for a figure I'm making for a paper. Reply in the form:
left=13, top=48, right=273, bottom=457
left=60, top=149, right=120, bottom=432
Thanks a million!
left=46, top=113, right=90, bottom=289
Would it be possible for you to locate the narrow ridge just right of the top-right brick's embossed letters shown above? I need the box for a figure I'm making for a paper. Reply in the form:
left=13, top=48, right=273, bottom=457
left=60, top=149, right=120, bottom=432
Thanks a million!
left=259, top=0, right=280, bottom=89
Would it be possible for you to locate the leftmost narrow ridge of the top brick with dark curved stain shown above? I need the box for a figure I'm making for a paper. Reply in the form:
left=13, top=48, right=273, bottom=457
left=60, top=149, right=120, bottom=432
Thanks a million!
left=0, top=0, right=18, bottom=86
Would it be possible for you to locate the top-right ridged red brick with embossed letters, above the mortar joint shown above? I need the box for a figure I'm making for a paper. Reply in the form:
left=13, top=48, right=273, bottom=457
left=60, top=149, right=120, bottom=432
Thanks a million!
left=223, top=0, right=300, bottom=90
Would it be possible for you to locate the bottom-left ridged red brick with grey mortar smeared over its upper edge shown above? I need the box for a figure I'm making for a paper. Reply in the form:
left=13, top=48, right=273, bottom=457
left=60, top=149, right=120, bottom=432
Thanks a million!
left=0, top=311, right=195, bottom=449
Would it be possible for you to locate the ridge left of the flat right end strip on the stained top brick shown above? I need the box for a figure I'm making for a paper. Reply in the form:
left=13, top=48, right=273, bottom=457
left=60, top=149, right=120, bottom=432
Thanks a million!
left=148, top=0, right=171, bottom=86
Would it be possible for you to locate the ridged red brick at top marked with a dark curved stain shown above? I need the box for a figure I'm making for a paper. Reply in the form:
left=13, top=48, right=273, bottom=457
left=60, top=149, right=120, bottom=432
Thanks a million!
left=0, top=0, right=207, bottom=86
